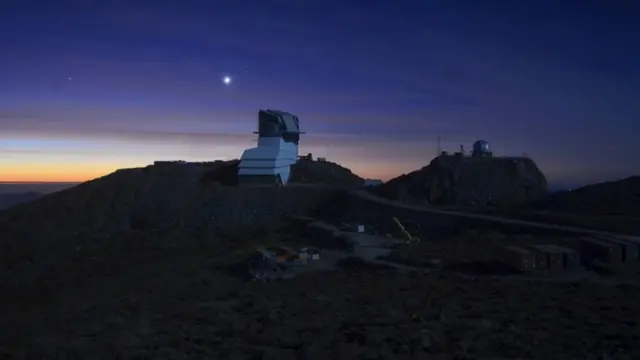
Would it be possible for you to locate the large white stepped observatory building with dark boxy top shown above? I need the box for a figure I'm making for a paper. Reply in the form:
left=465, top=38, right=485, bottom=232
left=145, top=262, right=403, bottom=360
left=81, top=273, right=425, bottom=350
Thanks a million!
left=238, top=109, right=301, bottom=185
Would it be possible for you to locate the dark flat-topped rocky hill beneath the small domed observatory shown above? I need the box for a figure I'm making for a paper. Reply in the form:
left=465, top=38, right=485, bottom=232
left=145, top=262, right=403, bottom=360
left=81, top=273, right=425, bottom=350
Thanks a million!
left=375, top=155, right=547, bottom=206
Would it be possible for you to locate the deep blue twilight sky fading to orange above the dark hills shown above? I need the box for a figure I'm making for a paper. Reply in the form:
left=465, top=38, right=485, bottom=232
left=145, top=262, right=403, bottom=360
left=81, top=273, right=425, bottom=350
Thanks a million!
left=0, top=0, right=640, bottom=185
